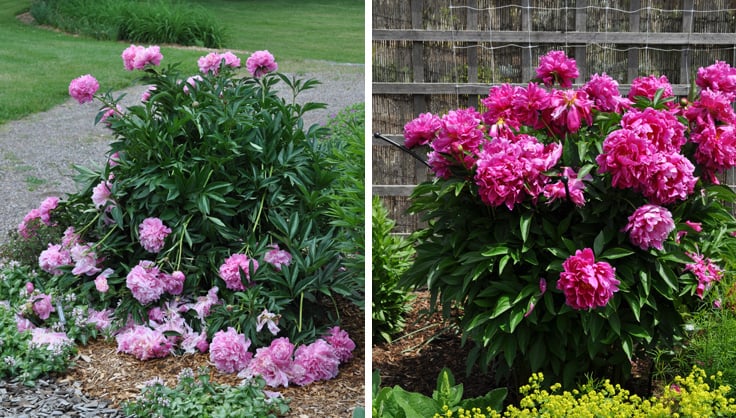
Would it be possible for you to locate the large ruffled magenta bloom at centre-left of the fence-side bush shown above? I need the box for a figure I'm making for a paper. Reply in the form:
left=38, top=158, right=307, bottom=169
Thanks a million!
left=475, top=135, right=562, bottom=210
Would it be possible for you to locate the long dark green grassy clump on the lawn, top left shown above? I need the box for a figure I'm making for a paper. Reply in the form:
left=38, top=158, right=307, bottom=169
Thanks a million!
left=30, top=0, right=225, bottom=48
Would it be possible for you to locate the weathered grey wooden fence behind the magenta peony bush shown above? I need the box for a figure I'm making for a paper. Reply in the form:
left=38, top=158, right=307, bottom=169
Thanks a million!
left=372, top=0, right=736, bottom=233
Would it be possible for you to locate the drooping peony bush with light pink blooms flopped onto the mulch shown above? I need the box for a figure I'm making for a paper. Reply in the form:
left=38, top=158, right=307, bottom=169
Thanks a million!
left=8, top=45, right=362, bottom=386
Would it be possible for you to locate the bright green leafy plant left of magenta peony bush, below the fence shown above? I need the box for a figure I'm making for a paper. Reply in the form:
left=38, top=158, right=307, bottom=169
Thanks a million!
left=371, top=196, right=414, bottom=342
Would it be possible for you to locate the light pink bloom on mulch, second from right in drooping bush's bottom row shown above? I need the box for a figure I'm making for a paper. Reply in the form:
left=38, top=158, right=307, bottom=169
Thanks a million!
left=292, top=338, right=340, bottom=386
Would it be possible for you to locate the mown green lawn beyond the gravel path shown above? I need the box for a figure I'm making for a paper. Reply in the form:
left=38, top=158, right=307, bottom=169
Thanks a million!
left=0, top=0, right=365, bottom=124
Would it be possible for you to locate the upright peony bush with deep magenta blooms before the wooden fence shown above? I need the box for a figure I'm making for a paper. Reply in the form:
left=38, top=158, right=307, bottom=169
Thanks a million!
left=403, top=51, right=736, bottom=387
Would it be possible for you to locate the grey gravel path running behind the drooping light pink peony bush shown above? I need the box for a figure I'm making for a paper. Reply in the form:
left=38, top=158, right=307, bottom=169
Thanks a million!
left=0, top=65, right=365, bottom=242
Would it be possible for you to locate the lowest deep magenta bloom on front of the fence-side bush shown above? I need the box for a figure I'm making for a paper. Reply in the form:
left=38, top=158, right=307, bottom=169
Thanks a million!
left=557, top=248, right=620, bottom=309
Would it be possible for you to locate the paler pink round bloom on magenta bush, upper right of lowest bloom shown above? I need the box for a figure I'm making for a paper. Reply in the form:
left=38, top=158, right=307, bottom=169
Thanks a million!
left=624, top=204, right=675, bottom=250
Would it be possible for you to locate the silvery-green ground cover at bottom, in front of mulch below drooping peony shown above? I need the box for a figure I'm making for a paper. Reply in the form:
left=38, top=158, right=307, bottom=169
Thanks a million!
left=123, top=369, right=289, bottom=418
